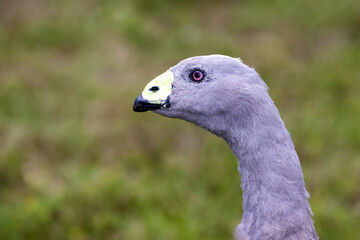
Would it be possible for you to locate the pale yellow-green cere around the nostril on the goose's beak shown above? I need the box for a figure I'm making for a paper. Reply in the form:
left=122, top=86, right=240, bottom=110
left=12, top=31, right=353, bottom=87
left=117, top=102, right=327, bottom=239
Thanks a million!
left=142, top=71, right=174, bottom=104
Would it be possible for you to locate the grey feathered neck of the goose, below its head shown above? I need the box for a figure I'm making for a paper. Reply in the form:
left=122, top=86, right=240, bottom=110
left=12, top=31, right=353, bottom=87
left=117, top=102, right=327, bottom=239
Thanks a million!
left=222, top=98, right=318, bottom=240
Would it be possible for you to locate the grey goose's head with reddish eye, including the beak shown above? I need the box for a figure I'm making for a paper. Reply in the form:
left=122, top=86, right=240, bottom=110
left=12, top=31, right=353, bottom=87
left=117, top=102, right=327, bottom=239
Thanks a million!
left=133, top=55, right=269, bottom=136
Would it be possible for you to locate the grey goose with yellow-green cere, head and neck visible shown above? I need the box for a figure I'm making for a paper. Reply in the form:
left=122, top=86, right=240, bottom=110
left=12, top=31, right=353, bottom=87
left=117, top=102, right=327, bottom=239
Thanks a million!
left=133, top=55, right=318, bottom=240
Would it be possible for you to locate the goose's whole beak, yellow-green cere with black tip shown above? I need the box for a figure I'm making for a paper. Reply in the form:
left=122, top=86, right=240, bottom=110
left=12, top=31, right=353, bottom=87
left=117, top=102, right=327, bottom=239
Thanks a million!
left=133, top=71, right=175, bottom=112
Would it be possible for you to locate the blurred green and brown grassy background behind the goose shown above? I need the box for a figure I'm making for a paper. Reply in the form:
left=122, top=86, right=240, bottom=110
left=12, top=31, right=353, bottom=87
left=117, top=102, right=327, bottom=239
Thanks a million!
left=0, top=0, right=360, bottom=240
